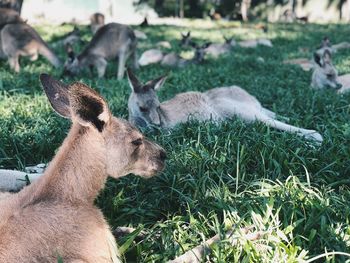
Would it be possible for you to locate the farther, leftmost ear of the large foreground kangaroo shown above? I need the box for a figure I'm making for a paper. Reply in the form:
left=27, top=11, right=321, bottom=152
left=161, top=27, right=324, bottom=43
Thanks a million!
left=40, top=74, right=70, bottom=118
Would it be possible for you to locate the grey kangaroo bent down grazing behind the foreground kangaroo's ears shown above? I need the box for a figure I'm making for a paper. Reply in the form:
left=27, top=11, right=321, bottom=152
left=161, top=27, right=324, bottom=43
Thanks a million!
left=64, top=23, right=138, bottom=80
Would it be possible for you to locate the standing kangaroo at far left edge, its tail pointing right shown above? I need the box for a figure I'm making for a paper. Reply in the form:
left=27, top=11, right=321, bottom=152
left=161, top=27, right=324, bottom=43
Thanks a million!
left=0, top=23, right=61, bottom=72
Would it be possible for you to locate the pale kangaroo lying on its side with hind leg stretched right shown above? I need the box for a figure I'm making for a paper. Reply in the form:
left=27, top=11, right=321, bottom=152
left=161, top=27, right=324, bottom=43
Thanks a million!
left=128, top=70, right=323, bottom=143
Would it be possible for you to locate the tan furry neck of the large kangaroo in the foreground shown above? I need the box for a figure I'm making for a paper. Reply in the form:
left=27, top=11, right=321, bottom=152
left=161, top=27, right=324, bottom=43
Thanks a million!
left=20, top=124, right=107, bottom=204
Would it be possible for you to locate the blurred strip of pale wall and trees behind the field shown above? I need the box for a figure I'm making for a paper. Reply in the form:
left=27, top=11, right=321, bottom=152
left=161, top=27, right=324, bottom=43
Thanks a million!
left=0, top=0, right=350, bottom=24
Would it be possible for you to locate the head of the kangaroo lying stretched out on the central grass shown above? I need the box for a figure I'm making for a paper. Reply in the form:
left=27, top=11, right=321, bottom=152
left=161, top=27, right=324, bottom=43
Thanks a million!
left=127, top=69, right=166, bottom=127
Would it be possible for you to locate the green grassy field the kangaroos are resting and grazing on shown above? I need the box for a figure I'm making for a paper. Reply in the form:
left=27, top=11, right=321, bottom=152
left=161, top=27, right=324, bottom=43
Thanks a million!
left=0, top=22, right=350, bottom=262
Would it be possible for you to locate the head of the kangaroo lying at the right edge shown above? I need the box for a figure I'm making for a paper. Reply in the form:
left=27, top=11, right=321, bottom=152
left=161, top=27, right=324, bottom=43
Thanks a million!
left=314, top=49, right=341, bottom=89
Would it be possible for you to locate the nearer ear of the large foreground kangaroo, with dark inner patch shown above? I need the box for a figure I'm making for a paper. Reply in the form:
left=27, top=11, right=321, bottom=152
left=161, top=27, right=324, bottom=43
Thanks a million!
left=69, top=82, right=111, bottom=132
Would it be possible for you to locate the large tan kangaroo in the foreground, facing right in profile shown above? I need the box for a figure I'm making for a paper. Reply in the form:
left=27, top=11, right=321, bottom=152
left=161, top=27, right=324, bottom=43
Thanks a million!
left=0, top=74, right=166, bottom=263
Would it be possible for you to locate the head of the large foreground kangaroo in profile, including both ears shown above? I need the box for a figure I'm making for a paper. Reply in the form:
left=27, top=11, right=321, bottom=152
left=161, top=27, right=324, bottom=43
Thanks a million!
left=40, top=74, right=166, bottom=178
